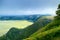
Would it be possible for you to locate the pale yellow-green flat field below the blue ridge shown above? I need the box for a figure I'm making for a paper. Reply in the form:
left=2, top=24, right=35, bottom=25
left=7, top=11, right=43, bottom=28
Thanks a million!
left=0, top=20, right=33, bottom=36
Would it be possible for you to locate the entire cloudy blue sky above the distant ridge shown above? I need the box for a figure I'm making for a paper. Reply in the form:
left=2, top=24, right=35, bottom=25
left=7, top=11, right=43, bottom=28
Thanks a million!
left=0, top=0, right=60, bottom=15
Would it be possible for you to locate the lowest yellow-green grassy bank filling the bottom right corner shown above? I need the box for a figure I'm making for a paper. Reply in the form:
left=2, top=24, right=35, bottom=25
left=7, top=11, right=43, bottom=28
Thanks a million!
left=23, top=26, right=60, bottom=40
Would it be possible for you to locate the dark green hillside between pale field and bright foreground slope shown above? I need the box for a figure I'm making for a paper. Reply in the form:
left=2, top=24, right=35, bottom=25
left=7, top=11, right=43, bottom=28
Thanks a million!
left=2, top=15, right=52, bottom=40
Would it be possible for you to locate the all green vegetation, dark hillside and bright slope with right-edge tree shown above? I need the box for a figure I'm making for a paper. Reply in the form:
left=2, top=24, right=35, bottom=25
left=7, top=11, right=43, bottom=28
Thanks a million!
left=0, top=4, right=60, bottom=40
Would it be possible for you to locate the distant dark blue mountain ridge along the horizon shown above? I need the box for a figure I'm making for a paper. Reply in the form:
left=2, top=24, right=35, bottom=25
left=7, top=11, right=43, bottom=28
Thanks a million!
left=0, top=14, right=49, bottom=22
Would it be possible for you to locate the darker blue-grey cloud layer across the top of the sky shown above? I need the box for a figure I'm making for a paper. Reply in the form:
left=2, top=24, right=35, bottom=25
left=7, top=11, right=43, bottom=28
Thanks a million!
left=2, top=0, right=60, bottom=10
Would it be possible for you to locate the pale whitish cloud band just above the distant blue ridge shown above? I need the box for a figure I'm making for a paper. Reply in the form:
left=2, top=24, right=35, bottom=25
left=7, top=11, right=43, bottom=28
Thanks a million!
left=0, top=8, right=56, bottom=15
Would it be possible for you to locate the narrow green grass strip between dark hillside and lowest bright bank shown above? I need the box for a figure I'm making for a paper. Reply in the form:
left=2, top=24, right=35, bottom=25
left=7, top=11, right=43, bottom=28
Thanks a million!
left=30, top=20, right=60, bottom=37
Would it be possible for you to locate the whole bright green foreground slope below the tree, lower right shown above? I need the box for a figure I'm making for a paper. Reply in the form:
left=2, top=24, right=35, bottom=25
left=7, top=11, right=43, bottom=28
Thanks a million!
left=25, top=20, right=60, bottom=40
